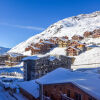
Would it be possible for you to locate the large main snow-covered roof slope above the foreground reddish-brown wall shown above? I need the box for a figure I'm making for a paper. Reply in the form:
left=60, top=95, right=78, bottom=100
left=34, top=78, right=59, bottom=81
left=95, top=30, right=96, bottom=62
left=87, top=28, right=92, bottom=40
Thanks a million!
left=37, top=68, right=100, bottom=100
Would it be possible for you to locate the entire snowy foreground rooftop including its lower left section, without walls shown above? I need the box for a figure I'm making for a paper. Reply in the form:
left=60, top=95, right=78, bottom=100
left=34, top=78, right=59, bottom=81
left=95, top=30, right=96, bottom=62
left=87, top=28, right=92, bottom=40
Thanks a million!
left=18, top=68, right=100, bottom=100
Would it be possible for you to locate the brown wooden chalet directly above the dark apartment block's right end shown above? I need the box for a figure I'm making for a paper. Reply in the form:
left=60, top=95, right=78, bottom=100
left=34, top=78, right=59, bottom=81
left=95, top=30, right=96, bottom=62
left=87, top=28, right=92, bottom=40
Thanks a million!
left=66, top=46, right=81, bottom=56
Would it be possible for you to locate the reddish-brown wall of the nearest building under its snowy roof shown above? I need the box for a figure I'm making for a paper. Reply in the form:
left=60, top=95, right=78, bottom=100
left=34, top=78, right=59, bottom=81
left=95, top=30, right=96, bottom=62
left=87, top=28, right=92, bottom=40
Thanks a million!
left=43, top=83, right=96, bottom=100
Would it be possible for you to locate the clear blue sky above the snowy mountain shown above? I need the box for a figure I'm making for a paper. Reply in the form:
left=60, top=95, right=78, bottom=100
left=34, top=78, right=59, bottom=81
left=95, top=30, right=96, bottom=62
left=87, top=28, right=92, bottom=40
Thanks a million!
left=0, top=0, right=100, bottom=48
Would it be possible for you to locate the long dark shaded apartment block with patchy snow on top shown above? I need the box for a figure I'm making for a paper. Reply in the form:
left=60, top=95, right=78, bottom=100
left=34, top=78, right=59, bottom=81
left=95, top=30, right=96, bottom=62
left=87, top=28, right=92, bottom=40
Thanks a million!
left=23, top=56, right=72, bottom=81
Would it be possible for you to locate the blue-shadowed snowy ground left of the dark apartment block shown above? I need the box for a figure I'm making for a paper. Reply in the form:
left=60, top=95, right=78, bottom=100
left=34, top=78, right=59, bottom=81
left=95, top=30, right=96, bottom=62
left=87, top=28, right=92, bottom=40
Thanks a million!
left=0, top=63, right=23, bottom=82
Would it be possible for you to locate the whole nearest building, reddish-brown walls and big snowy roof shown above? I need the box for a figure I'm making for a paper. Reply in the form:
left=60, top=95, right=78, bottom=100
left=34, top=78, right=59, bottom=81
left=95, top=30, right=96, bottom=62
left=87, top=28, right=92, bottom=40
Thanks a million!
left=19, top=68, right=100, bottom=100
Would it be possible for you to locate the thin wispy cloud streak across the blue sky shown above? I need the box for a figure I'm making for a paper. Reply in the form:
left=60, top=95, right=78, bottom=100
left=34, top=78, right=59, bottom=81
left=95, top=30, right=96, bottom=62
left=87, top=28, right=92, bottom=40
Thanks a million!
left=0, top=23, right=44, bottom=31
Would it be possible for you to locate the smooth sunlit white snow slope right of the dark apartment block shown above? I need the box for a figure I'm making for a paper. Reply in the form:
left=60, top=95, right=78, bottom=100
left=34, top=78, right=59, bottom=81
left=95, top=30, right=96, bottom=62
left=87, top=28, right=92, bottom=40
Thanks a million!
left=72, top=47, right=100, bottom=69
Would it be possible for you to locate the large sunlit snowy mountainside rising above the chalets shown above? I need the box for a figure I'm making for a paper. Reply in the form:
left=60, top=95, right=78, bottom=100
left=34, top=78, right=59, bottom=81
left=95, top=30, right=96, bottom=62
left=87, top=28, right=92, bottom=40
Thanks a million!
left=9, top=11, right=100, bottom=54
